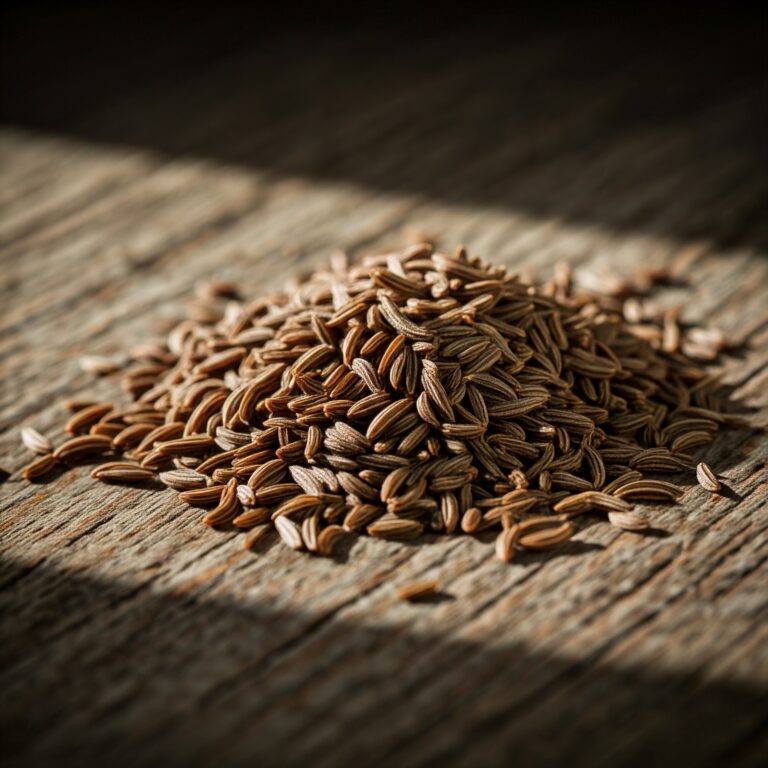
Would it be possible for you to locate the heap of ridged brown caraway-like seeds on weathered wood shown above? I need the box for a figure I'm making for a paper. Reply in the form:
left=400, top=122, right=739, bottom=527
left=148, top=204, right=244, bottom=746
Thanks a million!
left=23, top=244, right=730, bottom=560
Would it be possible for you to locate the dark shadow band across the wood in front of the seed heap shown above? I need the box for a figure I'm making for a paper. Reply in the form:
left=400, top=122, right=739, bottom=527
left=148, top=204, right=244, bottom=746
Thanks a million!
left=0, top=560, right=766, bottom=766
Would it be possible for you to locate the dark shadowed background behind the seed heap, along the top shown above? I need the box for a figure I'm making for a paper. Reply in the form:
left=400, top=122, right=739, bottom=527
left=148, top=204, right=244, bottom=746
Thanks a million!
left=0, top=2, right=768, bottom=247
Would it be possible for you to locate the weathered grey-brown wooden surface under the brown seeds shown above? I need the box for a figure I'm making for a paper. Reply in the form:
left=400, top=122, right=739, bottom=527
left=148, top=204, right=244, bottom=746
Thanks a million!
left=0, top=19, right=768, bottom=768
